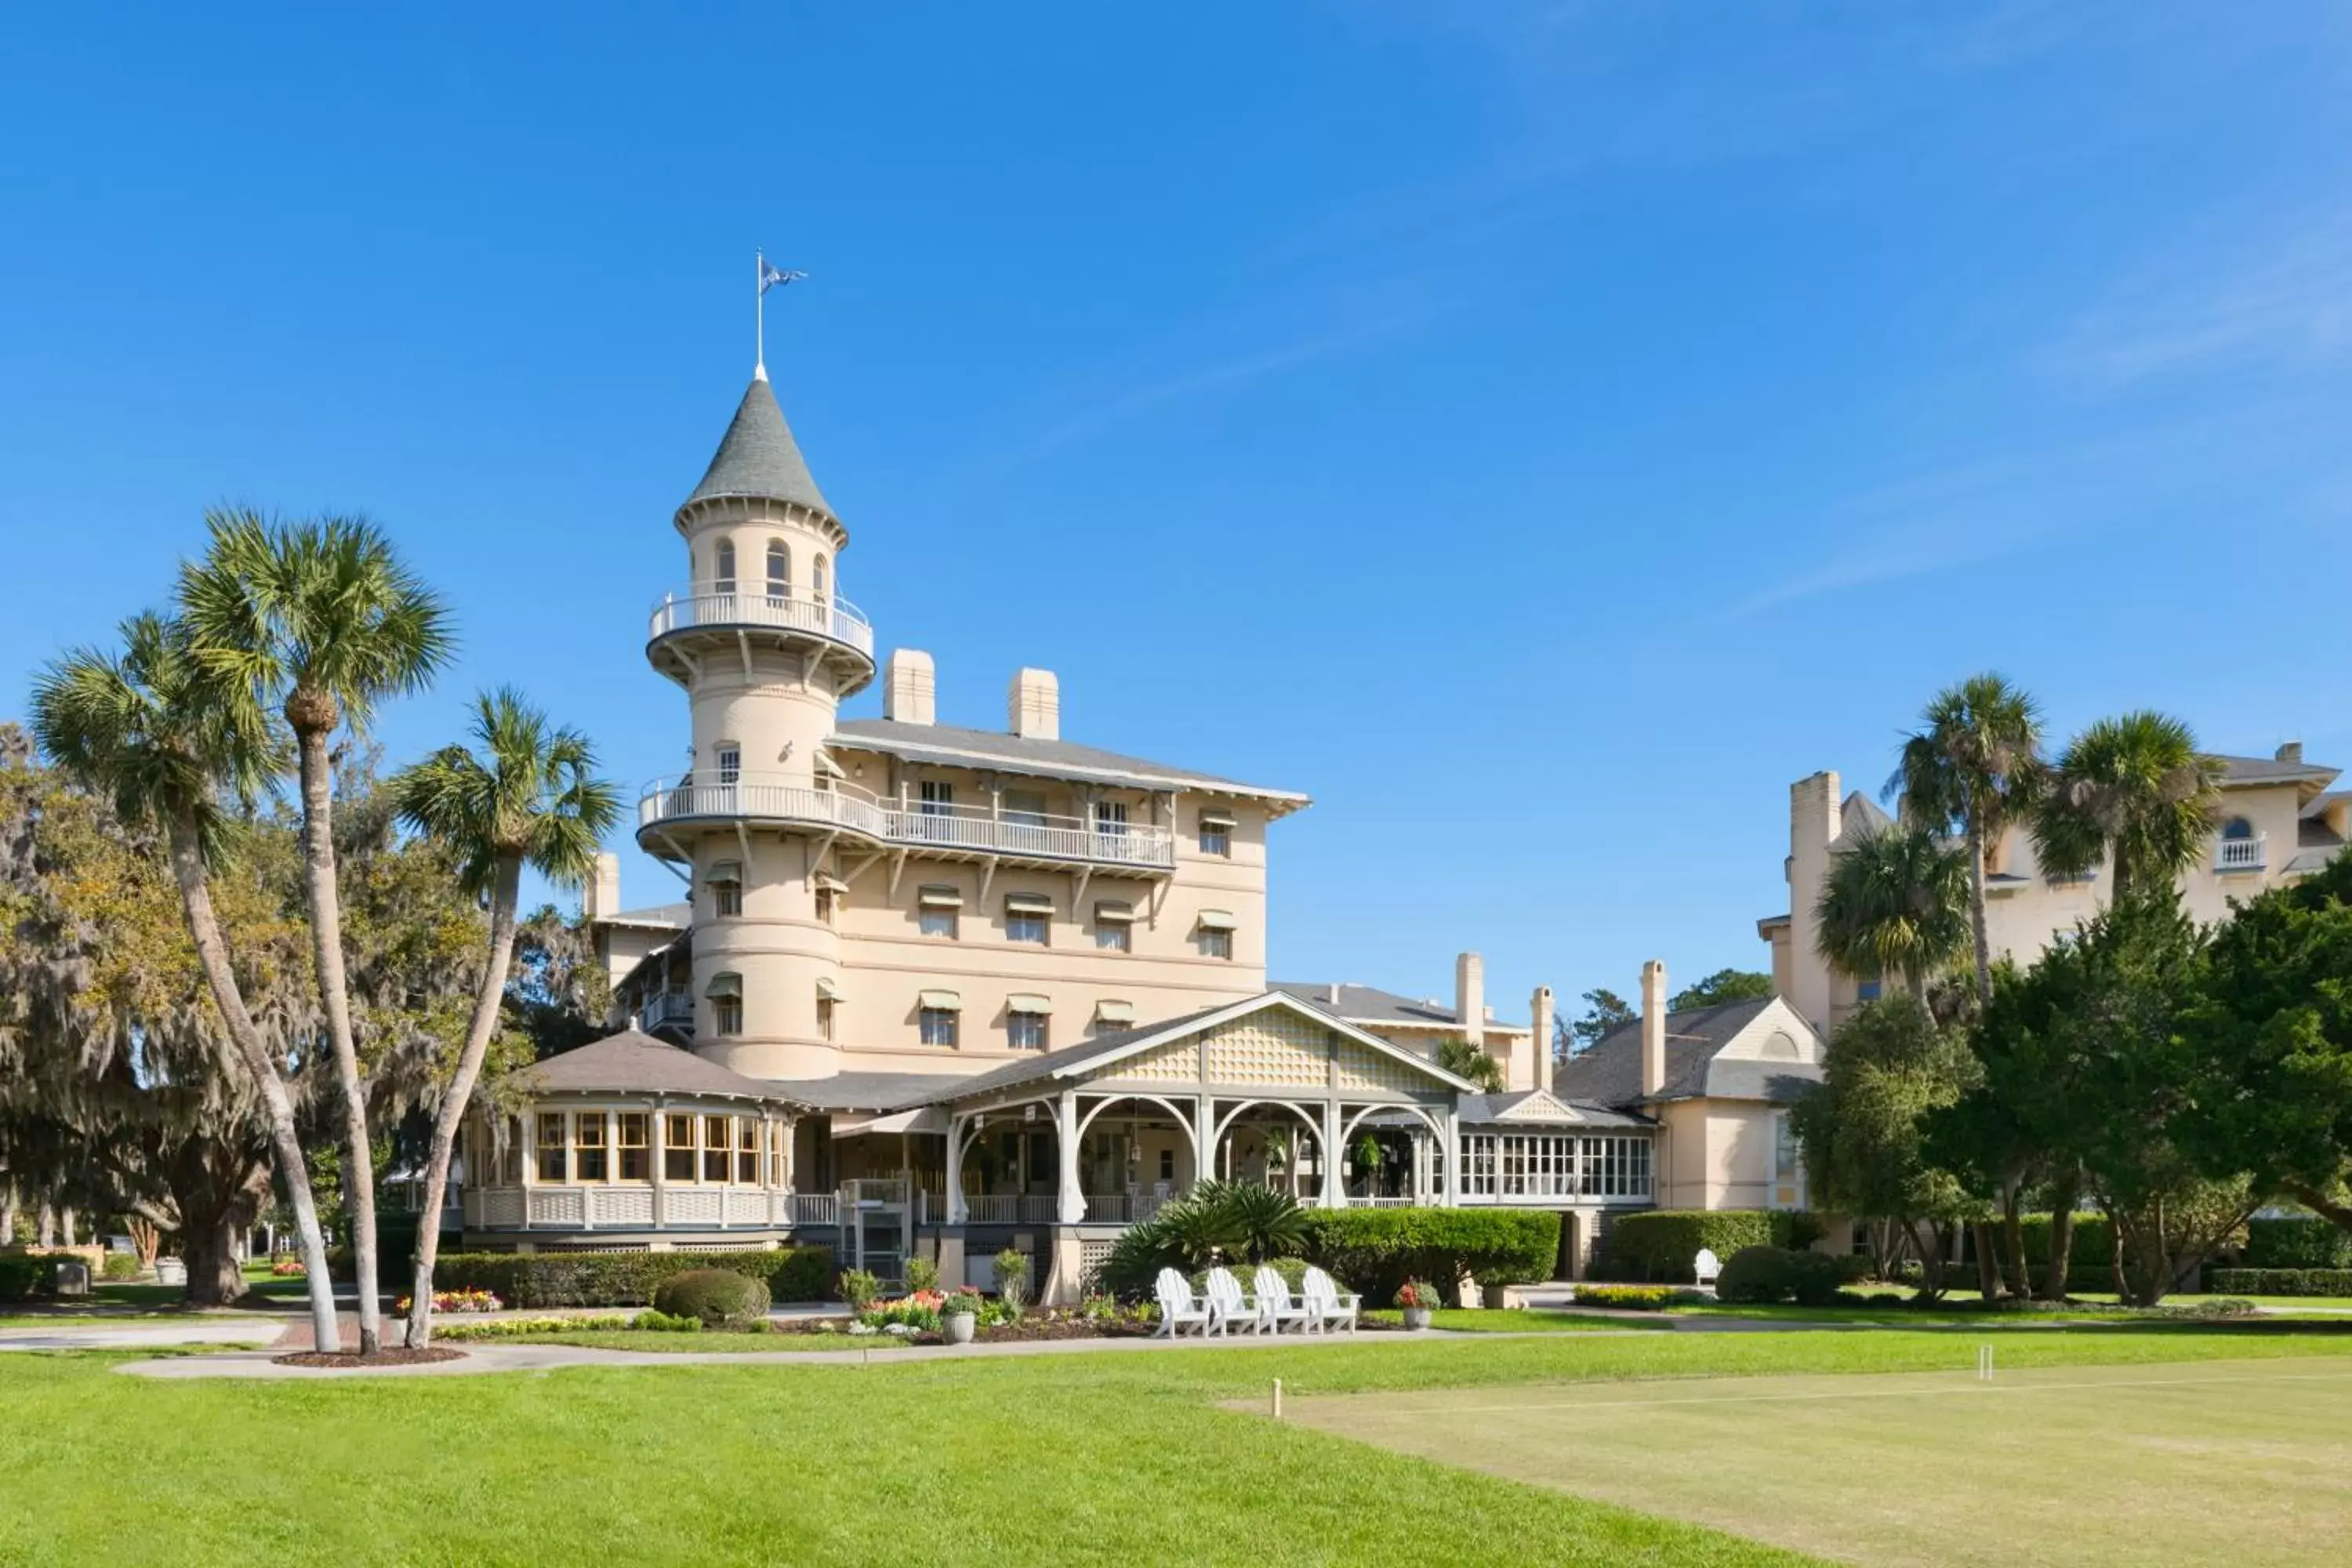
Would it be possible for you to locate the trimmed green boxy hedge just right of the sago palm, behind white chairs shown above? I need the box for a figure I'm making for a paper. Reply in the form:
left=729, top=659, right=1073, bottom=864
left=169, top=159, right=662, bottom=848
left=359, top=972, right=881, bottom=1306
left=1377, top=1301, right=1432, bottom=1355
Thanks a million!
left=1298, top=1208, right=1559, bottom=1307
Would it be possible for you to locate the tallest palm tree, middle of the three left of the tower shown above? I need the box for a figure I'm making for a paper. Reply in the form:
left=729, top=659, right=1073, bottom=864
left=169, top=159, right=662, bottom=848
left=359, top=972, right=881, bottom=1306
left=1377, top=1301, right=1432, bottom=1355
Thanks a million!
left=179, top=510, right=454, bottom=1354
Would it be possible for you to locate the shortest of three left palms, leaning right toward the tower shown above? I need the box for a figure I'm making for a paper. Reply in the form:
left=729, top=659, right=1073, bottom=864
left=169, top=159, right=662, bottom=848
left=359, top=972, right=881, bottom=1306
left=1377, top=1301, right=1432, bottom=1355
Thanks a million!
left=390, top=689, right=621, bottom=1347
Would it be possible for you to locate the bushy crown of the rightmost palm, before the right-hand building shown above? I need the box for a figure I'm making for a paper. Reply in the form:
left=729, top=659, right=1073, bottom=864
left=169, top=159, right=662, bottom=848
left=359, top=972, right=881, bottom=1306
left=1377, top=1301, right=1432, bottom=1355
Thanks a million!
left=2034, top=710, right=2220, bottom=900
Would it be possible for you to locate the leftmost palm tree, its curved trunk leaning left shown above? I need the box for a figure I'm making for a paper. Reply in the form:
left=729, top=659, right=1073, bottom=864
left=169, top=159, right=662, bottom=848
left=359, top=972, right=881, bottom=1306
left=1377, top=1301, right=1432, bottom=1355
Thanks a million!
left=33, top=614, right=341, bottom=1352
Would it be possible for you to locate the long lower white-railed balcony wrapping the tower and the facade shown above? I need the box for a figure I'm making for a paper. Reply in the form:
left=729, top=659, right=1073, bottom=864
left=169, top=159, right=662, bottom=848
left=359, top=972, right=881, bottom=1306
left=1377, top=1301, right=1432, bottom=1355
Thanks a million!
left=637, top=774, right=1176, bottom=872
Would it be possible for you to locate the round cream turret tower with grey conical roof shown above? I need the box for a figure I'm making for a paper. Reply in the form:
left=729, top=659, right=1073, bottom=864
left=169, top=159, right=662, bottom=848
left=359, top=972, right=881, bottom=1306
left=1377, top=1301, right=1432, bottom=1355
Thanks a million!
left=637, top=369, right=875, bottom=1079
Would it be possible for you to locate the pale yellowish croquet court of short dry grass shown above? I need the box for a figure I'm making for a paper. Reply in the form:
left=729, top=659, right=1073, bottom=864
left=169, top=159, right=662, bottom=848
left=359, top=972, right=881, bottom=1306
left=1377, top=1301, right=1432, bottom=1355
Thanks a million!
left=1289, top=1345, right=2352, bottom=1568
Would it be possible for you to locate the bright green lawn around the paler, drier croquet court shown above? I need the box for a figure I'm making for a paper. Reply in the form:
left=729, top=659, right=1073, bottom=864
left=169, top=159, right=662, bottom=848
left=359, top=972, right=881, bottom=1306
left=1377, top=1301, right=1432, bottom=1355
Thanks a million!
left=0, top=1314, right=2352, bottom=1568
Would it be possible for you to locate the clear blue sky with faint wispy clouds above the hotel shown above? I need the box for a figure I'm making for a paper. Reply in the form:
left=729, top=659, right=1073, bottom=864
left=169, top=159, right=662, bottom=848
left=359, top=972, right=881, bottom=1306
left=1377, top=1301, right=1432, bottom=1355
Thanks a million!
left=0, top=0, right=2352, bottom=1015
